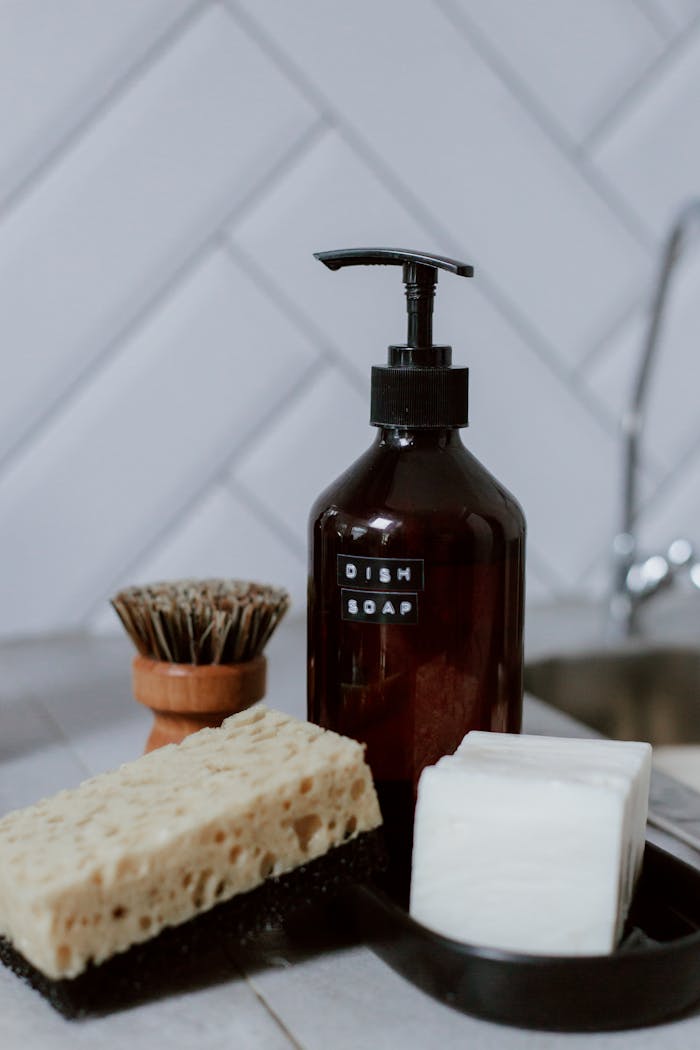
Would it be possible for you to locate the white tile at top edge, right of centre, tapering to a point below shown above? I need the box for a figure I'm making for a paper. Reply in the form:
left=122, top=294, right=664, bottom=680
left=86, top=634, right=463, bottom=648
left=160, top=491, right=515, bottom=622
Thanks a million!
left=454, top=0, right=663, bottom=142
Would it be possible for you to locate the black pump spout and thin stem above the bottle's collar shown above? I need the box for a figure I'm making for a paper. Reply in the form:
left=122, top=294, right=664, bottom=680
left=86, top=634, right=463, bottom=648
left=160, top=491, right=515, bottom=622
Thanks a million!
left=315, top=248, right=474, bottom=349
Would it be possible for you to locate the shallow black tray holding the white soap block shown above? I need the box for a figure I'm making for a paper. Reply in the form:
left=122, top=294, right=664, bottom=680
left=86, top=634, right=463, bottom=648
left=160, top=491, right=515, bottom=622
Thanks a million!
left=347, top=842, right=700, bottom=1032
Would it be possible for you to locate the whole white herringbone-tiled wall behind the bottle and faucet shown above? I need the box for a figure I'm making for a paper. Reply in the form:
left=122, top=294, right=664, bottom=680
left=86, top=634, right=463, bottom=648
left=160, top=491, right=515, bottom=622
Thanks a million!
left=0, top=0, right=700, bottom=636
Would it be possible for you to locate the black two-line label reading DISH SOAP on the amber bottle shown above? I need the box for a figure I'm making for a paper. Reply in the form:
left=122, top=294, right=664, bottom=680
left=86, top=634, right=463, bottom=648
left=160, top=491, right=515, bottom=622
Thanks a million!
left=338, top=554, right=424, bottom=624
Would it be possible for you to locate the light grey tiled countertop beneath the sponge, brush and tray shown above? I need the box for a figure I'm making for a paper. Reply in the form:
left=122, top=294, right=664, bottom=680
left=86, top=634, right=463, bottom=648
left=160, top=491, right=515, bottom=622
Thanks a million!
left=0, top=620, right=700, bottom=1050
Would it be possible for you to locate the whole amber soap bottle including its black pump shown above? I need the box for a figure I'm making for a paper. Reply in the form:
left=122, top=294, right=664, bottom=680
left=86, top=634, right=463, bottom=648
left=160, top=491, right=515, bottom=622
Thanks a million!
left=309, top=248, right=525, bottom=877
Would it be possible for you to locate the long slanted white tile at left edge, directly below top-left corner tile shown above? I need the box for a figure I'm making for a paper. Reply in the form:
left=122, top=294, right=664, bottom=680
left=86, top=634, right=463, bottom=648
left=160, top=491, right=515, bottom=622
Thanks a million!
left=0, top=8, right=313, bottom=464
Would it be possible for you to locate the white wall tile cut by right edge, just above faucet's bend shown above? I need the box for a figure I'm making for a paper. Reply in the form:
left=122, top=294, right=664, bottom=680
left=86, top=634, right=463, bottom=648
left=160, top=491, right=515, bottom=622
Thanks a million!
left=593, top=29, right=700, bottom=238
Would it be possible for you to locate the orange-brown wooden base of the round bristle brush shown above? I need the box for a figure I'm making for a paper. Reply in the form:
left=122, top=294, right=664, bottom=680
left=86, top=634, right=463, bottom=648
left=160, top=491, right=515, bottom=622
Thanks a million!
left=131, top=656, right=268, bottom=751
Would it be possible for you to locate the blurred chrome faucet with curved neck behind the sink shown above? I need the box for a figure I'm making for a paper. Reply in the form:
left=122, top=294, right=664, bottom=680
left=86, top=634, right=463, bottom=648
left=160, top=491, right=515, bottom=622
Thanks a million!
left=608, top=198, right=700, bottom=637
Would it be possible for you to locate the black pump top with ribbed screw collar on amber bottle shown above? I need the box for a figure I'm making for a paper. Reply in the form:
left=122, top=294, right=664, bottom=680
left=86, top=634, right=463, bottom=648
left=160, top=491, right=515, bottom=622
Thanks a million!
left=316, top=248, right=474, bottom=428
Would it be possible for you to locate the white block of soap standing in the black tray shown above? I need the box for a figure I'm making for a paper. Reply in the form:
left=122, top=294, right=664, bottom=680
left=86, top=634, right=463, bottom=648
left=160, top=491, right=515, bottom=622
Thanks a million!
left=410, top=733, right=652, bottom=956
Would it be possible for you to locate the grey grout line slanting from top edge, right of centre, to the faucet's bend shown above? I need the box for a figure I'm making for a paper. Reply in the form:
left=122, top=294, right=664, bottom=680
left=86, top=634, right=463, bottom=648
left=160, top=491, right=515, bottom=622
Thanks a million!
left=433, top=0, right=655, bottom=252
